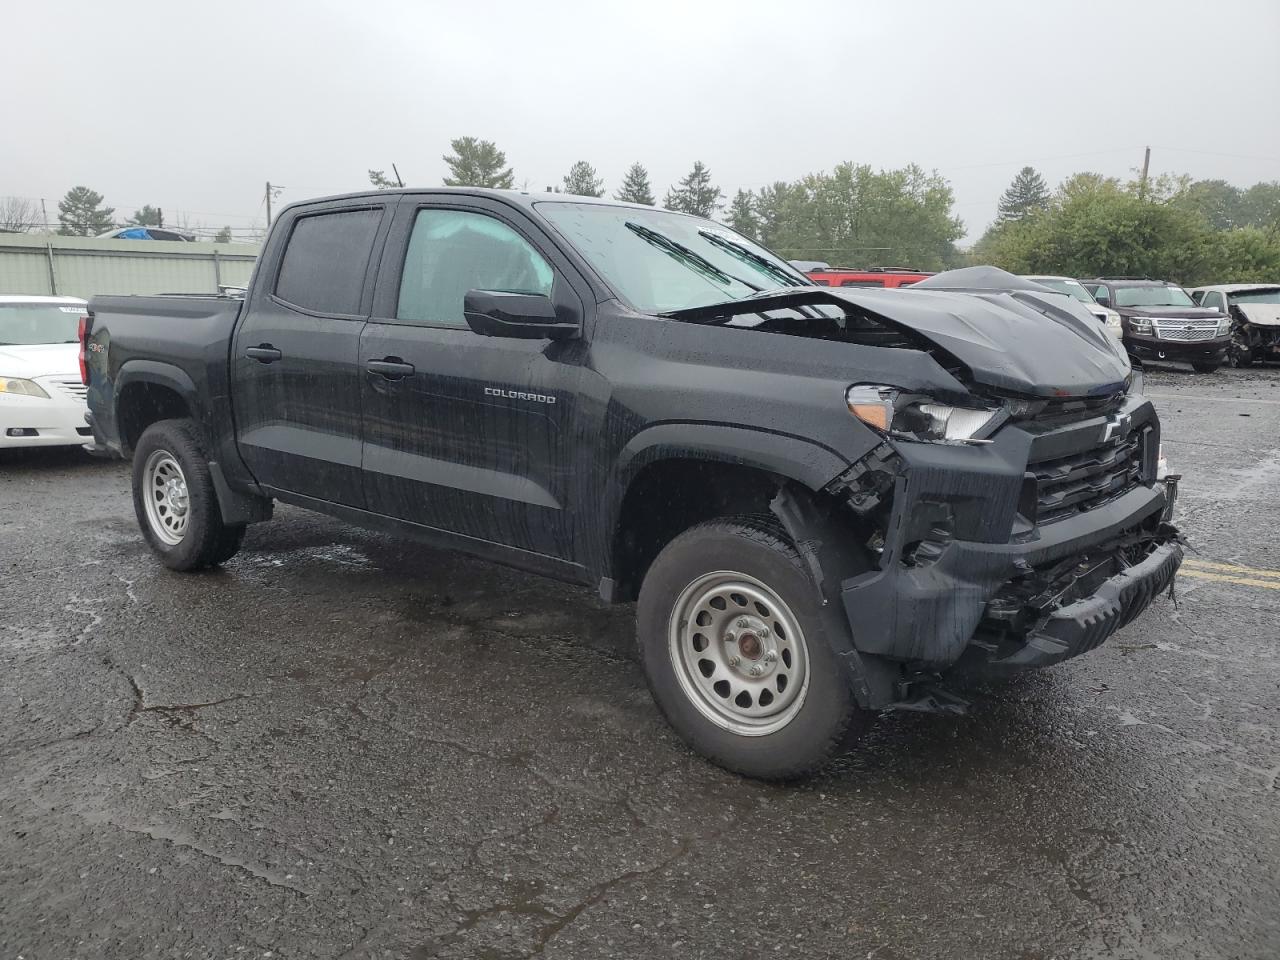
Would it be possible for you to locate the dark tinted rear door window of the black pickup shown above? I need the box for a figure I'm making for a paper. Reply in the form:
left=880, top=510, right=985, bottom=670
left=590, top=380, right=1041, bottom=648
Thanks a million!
left=275, top=210, right=383, bottom=314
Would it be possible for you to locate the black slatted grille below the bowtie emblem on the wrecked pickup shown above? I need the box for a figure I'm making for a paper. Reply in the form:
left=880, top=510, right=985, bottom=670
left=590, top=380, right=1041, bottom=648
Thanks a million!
left=1028, top=430, right=1146, bottom=524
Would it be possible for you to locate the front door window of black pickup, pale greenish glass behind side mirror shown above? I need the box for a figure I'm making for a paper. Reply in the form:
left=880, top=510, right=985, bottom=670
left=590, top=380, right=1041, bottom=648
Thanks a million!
left=396, top=210, right=556, bottom=326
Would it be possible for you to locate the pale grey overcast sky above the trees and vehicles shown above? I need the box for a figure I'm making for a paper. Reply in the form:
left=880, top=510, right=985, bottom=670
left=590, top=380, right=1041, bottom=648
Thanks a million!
left=10, top=0, right=1280, bottom=239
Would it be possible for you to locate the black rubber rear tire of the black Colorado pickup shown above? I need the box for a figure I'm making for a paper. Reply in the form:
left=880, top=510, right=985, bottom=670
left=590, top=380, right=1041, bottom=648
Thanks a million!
left=133, top=420, right=244, bottom=571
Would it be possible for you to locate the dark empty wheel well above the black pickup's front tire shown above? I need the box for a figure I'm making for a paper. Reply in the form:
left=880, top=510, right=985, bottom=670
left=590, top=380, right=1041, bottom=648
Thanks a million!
left=611, top=458, right=782, bottom=600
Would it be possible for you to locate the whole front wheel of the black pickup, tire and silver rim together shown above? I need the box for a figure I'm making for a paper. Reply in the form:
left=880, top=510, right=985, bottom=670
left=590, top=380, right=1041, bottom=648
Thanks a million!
left=637, top=517, right=867, bottom=780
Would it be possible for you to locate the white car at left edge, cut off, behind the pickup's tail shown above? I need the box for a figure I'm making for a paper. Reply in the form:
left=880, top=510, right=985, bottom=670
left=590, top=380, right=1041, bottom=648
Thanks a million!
left=0, top=296, right=92, bottom=449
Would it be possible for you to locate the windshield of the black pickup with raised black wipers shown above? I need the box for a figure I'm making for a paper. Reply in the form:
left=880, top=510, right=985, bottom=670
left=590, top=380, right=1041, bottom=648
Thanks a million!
left=538, top=201, right=812, bottom=314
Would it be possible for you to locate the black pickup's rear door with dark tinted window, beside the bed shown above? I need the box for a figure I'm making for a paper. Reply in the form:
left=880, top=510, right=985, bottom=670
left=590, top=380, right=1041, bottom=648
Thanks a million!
left=232, top=200, right=390, bottom=507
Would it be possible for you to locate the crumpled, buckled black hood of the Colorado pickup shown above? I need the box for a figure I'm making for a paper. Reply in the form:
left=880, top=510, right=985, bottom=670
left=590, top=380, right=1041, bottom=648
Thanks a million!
left=669, top=268, right=1132, bottom=397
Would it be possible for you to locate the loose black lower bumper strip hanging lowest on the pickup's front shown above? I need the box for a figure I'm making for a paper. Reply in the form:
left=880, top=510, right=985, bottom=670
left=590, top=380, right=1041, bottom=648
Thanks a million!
left=991, top=543, right=1183, bottom=668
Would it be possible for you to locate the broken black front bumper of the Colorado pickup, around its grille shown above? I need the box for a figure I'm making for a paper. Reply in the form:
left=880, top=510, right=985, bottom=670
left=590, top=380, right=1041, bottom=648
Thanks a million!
left=840, top=397, right=1181, bottom=672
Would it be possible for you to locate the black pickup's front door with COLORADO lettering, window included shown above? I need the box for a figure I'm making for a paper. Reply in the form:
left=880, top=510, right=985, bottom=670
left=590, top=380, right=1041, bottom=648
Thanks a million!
left=360, top=197, right=585, bottom=559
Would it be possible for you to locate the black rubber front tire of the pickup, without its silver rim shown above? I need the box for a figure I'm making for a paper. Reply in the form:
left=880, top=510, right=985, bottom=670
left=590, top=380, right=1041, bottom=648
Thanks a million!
left=636, top=517, right=870, bottom=780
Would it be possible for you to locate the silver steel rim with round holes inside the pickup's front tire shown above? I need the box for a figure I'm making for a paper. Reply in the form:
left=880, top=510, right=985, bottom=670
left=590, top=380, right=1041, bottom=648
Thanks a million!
left=668, top=570, right=809, bottom=736
